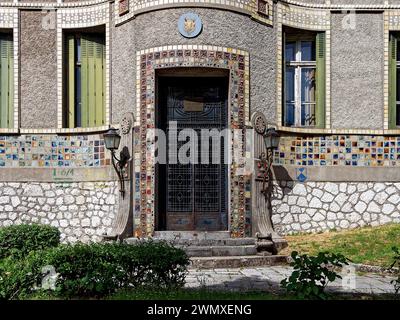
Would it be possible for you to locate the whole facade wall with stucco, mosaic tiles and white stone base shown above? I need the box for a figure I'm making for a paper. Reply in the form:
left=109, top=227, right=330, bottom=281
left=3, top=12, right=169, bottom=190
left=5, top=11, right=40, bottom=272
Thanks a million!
left=0, top=0, right=400, bottom=242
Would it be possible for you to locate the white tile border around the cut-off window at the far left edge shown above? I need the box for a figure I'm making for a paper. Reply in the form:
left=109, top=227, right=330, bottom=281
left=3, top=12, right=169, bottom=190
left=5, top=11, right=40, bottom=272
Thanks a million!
left=0, top=8, right=19, bottom=133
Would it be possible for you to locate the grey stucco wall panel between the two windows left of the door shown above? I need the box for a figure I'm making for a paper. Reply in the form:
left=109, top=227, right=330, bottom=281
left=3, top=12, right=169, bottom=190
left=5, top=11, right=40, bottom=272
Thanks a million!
left=20, top=11, right=57, bottom=128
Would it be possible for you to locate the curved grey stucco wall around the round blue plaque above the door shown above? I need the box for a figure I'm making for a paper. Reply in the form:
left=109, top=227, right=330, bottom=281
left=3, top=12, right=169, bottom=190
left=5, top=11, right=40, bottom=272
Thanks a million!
left=112, top=8, right=276, bottom=123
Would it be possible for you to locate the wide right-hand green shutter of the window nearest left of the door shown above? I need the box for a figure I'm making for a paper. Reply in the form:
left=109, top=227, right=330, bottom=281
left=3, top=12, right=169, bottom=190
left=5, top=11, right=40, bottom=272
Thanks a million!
left=81, top=35, right=105, bottom=127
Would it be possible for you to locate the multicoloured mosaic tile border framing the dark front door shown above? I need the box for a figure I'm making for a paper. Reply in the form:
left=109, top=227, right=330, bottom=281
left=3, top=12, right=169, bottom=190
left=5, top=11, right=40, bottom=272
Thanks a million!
left=134, top=45, right=251, bottom=237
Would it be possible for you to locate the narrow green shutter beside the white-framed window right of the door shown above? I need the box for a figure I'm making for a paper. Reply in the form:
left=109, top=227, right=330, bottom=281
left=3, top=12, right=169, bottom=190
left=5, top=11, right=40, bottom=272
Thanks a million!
left=315, top=32, right=326, bottom=129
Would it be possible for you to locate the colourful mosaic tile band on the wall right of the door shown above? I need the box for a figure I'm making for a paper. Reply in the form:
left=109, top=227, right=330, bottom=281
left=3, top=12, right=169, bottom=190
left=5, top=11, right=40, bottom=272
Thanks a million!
left=274, top=135, right=400, bottom=167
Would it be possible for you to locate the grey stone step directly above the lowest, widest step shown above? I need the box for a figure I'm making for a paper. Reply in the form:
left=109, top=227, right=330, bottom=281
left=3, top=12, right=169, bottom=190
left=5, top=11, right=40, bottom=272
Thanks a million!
left=183, top=245, right=257, bottom=257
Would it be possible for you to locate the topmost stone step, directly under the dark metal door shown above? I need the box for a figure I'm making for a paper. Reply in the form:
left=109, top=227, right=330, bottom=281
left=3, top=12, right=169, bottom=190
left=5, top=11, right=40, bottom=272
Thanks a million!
left=153, top=231, right=231, bottom=240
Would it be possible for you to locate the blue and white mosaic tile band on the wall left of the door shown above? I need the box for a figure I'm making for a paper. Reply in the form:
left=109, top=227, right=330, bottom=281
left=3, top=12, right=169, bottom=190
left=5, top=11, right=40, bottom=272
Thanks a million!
left=0, top=135, right=110, bottom=169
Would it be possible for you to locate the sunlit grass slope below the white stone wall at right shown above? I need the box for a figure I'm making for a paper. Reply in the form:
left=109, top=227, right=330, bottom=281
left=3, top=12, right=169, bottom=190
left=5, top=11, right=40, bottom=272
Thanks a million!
left=282, top=224, right=400, bottom=267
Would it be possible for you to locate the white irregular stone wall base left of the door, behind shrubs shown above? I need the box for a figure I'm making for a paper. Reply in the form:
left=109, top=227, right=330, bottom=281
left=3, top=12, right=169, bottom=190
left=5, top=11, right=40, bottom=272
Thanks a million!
left=0, top=182, right=118, bottom=242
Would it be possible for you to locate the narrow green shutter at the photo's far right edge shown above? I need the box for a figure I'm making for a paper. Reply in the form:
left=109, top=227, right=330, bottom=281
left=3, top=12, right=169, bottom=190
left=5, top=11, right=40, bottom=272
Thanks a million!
left=389, top=34, right=397, bottom=129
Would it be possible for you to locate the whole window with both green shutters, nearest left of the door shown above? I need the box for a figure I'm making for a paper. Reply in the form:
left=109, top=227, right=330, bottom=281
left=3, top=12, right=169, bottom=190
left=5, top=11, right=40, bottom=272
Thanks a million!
left=66, top=33, right=105, bottom=128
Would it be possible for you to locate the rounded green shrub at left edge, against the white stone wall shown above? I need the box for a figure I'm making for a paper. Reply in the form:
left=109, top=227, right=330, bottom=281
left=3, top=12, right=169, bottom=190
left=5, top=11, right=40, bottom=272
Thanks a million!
left=0, top=224, right=60, bottom=259
